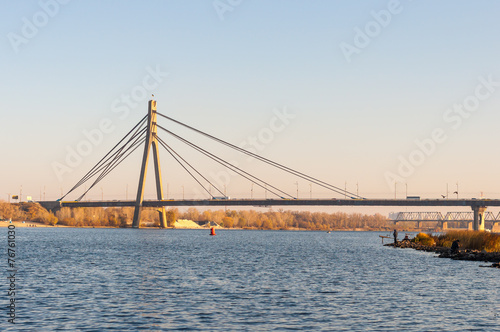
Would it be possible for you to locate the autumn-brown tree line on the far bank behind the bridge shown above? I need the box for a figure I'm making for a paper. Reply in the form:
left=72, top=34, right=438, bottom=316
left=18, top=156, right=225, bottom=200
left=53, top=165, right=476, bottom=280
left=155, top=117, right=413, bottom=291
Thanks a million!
left=0, top=202, right=390, bottom=230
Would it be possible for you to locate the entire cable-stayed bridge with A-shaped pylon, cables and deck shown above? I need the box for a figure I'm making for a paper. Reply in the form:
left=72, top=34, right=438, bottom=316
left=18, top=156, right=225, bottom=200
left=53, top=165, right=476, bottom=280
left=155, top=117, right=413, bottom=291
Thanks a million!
left=39, top=100, right=500, bottom=230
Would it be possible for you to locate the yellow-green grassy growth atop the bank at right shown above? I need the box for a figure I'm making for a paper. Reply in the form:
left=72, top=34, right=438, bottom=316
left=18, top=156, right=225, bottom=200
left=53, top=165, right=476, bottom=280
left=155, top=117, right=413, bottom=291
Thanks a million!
left=413, top=231, right=500, bottom=252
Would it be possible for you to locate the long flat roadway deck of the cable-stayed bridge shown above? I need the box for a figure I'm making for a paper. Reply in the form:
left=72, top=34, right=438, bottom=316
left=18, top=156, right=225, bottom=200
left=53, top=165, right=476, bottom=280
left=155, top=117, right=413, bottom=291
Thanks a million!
left=38, top=198, right=500, bottom=210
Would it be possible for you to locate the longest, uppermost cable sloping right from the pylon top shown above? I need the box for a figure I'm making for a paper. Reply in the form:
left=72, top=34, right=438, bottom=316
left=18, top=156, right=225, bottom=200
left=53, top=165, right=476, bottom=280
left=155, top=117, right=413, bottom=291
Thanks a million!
left=157, top=112, right=363, bottom=198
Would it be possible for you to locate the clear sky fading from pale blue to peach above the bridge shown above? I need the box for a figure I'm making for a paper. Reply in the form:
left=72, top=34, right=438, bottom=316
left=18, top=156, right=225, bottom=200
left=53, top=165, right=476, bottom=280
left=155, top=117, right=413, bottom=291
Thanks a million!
left=0, top=0, right=500, bottom=211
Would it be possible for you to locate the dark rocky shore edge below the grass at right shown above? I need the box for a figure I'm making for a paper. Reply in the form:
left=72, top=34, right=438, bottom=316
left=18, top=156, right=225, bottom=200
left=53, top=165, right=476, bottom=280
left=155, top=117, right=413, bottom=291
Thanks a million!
left=385, top=241, right=500, bottom=268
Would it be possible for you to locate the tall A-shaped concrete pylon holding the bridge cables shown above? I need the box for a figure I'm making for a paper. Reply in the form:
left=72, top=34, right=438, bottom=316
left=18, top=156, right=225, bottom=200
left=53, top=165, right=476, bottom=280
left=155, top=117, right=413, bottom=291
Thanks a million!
left=132, top=100, right=167, bottom=228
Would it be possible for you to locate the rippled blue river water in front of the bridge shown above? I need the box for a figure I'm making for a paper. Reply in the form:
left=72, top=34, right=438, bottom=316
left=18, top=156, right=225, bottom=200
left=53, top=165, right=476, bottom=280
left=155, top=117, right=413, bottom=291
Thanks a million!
left=0, top=228, right=500, bottom=331
